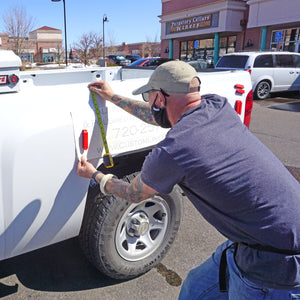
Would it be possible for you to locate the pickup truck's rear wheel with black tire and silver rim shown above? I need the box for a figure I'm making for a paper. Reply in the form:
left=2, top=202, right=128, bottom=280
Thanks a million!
left=79, top=173, right=183, bottom=279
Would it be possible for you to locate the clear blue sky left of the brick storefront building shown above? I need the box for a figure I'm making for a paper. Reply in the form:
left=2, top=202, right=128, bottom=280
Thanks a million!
left=0, top=0, right=161, bottom=46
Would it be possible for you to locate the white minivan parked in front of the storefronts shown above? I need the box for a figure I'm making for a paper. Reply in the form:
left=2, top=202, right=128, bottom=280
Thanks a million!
left=215, top=52, right=300, bottom=100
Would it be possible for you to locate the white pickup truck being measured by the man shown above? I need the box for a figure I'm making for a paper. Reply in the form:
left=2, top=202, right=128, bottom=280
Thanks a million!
left=0, top=51, right=252, bottom=278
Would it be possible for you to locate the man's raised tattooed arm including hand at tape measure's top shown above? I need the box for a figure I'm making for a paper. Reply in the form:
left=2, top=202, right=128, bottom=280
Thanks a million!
left=88, top=80, right=157, bottom=125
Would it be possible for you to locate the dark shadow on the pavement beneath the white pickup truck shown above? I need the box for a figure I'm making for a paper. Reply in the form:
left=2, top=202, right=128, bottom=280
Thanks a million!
left=0, top=238, right=122, bottom=297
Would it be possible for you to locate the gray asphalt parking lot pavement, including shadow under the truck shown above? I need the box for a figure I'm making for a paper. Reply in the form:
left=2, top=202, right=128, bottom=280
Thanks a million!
left=0, top=94, right=300, bottom=300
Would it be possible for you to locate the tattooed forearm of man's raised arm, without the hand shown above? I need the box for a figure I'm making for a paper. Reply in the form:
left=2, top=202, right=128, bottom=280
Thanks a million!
left=110, top=95, right=157, bottom=125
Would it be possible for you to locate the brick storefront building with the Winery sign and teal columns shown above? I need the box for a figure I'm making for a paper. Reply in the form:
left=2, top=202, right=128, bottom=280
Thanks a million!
left=159, top=0, right=300, bottom=63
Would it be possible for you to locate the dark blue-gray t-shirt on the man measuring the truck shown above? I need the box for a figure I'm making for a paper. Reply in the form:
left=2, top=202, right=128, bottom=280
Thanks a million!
left=141, top=95, right=300, bottom=289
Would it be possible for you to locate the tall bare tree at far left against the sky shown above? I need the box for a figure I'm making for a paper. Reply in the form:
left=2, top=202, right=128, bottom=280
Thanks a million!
left=2, top=5, right=34, bottom=55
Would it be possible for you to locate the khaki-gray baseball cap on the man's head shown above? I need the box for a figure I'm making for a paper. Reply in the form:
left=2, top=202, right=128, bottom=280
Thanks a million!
left=132, top=60, right=200, bottom=95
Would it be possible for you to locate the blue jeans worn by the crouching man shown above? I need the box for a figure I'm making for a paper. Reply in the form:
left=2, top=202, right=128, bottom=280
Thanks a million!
left=178, top=241, right=300, bottom=300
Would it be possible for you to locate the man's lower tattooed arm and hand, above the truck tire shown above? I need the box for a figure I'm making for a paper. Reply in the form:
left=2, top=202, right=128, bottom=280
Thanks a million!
left=77, top=157, right=158, bottom=203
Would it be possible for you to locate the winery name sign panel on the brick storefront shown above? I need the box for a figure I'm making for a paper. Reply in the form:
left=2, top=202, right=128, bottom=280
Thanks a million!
left=170, top=15, right=211, bottom=33
